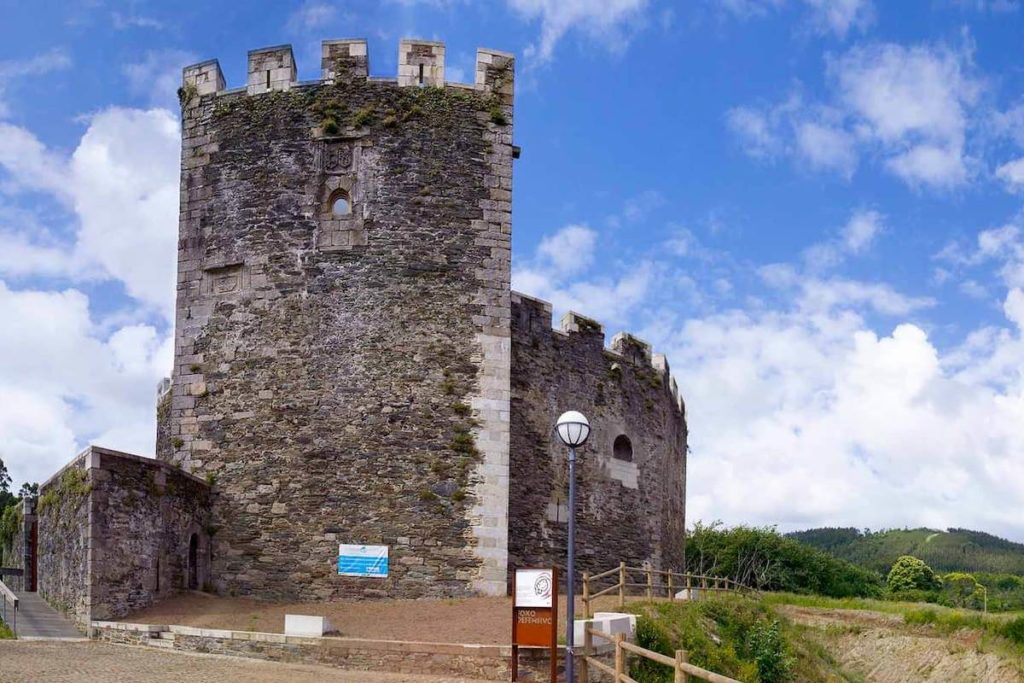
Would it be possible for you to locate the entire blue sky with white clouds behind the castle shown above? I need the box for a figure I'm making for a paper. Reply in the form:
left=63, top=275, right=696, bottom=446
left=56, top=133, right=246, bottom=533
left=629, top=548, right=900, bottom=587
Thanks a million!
left=0, top=0, right=1024, bottom=540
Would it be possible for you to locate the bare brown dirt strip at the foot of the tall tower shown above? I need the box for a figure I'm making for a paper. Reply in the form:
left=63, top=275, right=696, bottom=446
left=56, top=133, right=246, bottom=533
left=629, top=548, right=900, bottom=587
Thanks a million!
left=121, top=593, right=617, bottom=645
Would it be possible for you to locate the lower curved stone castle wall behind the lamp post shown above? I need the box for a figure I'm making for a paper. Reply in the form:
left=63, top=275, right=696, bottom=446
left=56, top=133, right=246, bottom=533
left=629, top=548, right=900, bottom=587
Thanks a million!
left=509, top=293, right=686, bottom=572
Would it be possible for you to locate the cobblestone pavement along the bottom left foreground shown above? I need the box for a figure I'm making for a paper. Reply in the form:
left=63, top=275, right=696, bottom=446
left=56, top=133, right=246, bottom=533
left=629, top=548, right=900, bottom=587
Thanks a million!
left=0, top=641, right=499, bottom=683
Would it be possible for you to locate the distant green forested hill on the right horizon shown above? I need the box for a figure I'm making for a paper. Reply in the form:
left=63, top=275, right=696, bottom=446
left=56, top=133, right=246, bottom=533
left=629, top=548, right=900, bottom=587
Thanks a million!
left=786, top=528, right=1024, bottom=575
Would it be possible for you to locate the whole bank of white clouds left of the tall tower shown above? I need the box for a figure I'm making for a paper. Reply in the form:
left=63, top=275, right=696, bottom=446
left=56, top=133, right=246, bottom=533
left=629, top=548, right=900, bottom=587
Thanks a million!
left=0, top=109, right=180, bottom=481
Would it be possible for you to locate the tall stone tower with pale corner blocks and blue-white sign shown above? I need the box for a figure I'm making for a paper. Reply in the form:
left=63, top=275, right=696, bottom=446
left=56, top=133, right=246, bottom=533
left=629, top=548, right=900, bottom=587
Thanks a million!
left=169, top=41, right=513, bottom=599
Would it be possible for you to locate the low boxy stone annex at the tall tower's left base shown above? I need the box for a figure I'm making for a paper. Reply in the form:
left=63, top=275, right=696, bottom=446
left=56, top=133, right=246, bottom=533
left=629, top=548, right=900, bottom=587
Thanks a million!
left=38, top=446, right=212, bottom=627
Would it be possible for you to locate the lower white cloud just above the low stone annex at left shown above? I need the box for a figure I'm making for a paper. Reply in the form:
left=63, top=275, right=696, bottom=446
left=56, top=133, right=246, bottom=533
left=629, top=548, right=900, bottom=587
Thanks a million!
left=0, top=282, right=172, bottom=482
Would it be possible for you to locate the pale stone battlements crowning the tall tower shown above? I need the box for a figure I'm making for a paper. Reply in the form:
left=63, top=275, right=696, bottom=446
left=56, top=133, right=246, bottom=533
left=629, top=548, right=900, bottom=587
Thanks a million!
left=181, top=38, right=515, bottom=102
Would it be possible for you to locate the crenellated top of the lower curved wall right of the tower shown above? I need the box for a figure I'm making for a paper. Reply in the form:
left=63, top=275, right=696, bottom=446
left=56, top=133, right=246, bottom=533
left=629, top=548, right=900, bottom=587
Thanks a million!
left=512, top=292, right=685, bottom=413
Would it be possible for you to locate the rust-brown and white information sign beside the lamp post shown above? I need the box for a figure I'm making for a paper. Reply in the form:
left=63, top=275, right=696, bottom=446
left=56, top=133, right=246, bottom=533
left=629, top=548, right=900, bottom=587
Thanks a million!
left=512, top=567, right=558, bottom=683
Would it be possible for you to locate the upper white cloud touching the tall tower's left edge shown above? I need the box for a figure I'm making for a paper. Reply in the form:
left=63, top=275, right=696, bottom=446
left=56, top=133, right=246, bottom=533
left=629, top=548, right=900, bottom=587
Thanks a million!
left=0, top=109, right=180, bottom=321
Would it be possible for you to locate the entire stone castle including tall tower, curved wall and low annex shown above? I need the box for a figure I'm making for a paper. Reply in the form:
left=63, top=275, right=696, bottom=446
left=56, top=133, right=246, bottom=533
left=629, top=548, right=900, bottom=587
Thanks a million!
left=39, top=40, right=686, bottom=622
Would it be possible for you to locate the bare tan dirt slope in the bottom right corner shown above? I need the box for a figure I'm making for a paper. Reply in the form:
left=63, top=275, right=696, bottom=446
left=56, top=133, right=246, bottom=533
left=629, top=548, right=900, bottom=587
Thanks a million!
left=778, top=606, right=1024, bottom=683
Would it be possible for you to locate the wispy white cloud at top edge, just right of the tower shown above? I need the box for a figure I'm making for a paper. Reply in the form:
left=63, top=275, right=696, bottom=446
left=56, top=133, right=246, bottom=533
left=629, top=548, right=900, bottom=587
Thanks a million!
left=507, top=0, right=647, bottom=63
